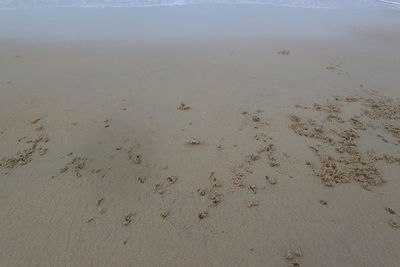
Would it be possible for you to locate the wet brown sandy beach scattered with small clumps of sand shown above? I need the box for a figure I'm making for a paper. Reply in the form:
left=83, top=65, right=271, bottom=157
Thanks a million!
left=0, top=4, right=400, bottom=266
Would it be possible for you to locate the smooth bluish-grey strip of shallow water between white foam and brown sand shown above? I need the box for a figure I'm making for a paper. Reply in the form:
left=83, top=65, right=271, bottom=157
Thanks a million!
left=0, top=4, right=400, bottom=43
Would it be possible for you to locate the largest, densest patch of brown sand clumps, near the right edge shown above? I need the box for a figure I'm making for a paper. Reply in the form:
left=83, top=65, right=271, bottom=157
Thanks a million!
left=289, top=92, right=399, bottom=190
